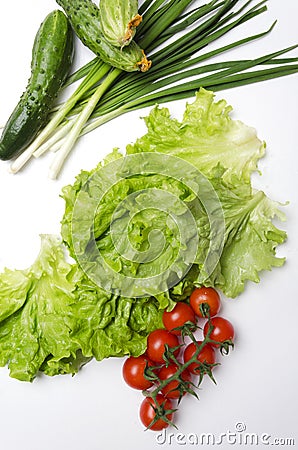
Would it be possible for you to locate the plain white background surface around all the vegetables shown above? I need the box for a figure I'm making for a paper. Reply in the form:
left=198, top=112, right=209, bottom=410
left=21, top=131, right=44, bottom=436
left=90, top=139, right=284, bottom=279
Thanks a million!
left=0, top=0, right=298, bottom=450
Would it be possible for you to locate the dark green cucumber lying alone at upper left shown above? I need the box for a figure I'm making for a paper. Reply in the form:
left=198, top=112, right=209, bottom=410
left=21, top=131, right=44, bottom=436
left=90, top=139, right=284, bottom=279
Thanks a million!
left=0, top=10, right=73, bottom=160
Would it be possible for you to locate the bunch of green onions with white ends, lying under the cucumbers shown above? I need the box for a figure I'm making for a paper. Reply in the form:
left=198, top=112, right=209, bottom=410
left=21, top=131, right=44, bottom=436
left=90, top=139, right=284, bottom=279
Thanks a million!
left=11, top=0, right=298, bottom=179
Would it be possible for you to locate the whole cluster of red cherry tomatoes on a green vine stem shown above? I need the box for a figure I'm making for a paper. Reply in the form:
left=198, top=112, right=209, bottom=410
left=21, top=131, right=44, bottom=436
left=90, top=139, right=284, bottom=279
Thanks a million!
left=123, top=289, right=235, bottom=431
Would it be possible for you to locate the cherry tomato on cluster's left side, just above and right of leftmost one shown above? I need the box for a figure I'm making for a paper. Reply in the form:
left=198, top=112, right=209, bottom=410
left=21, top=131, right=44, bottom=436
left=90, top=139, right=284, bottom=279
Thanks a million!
left=146, top=328, right=179, bottom=364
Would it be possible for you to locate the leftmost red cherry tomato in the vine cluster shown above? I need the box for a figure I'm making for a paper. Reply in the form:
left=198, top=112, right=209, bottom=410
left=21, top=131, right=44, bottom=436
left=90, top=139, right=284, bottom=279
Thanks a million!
left=122, top=355, right=153, bottom=390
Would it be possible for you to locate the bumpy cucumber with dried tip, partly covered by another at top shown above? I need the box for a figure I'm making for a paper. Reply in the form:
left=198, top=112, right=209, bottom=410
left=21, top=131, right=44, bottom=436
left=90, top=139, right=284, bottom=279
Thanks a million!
left=56, top=0, right=151, bottom=72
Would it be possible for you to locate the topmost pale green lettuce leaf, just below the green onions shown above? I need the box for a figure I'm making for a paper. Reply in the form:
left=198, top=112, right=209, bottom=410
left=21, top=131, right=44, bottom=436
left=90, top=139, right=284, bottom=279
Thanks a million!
left=126, top=88, right=265, bottom=182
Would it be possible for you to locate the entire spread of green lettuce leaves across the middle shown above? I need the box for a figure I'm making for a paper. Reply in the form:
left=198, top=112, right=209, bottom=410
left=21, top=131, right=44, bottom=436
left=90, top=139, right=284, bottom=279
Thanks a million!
left=0, top=89, right=286, bottom=381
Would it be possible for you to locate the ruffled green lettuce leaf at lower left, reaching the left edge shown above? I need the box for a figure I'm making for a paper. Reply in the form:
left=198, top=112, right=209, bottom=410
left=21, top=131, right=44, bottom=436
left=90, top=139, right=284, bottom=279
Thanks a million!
left=0, top=235, right=162, bottom=381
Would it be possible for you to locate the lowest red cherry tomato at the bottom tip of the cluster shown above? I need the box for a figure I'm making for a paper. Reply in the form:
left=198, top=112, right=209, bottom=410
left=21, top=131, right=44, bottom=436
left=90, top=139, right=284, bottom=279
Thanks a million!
left=140, top=394, right=173, bottom=431
